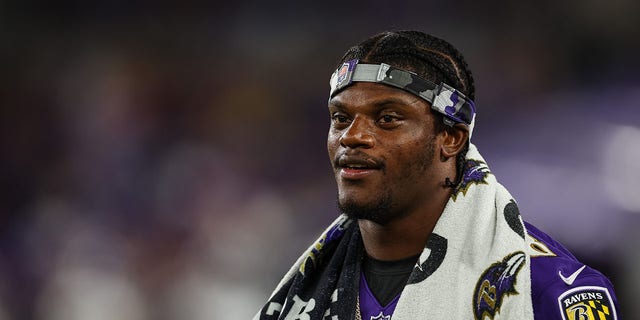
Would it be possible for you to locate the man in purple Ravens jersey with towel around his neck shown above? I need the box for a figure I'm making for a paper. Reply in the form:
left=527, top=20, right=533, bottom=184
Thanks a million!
left=254, top=31, right=618, bottom=320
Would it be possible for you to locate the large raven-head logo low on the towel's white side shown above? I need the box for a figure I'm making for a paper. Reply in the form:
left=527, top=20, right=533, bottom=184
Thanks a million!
left=473, top=251, right=526, bottom=320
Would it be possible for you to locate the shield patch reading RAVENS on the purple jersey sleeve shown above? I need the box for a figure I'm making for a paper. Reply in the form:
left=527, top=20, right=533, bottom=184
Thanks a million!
left=558, top=287, right=617, bottom=320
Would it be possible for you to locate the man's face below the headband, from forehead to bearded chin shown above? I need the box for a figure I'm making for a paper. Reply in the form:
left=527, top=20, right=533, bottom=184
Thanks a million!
left=327, top=82, right=439, bottom=224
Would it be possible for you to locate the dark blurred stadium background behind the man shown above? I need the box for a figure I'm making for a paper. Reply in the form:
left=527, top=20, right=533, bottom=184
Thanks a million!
left=0, top=0, right=640, bottom=320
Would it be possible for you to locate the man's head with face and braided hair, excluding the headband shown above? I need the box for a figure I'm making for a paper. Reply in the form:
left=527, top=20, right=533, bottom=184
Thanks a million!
left=327, top=31, right=475, bottom=224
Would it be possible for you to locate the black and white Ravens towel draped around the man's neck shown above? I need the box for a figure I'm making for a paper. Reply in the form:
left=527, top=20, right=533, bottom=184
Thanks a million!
left=254, top=144, right=533, bottom=320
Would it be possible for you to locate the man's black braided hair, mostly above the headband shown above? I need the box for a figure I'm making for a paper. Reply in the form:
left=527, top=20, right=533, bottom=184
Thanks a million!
left=336, top=31, right=475, bottom=185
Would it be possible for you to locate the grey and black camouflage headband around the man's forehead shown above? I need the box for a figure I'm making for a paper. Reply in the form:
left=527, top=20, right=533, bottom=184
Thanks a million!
left=329, top=59, right=476, bottom=138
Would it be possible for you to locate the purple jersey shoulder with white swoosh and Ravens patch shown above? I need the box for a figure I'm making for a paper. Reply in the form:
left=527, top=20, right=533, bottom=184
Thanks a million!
left=525, top=222, right=618, bottom=320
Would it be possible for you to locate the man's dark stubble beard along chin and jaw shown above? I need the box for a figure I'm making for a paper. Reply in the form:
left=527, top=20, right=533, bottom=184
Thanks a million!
left=338, top=137, right=435, bottom=225
